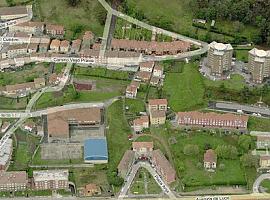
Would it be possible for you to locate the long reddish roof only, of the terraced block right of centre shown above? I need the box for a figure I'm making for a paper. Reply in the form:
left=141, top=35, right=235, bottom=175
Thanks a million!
left=177, top=111, right=248, bottom=123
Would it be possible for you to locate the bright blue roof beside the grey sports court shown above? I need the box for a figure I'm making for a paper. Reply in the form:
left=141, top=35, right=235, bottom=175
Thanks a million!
left=84, top=138, right=108, bottom=161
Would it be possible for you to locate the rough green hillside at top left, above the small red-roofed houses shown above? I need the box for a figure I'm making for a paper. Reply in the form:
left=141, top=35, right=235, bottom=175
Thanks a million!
left=35, top=0, right=105, bottom=39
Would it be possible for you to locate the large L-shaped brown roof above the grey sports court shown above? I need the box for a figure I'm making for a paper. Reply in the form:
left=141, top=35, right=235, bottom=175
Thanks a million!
left=47, top=107, right=101, bottom=138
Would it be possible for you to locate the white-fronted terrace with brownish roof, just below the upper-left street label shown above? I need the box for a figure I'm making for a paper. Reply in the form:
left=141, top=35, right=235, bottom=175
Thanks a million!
left=2, top=44, right=28, bottom=59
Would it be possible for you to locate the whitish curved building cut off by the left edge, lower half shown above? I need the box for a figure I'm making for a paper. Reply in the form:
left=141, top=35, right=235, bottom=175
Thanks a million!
left=0, top=139, right=13, bottom=170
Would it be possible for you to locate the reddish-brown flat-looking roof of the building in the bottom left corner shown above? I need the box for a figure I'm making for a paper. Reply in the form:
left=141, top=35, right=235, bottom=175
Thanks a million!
left=0, top=171, right=28, bottom=185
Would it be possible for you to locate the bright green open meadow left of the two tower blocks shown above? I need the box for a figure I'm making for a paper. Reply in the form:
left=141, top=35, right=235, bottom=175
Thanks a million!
left=164, top=62, right=205, bottom=111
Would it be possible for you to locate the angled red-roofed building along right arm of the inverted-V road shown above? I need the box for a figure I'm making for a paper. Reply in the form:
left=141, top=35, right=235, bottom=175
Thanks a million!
left=152, top=149, right=176, bottom=184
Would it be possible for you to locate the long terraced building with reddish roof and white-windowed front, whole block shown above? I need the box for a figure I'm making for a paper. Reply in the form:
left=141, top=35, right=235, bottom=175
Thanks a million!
left=177, top=111, right=248, bottom=131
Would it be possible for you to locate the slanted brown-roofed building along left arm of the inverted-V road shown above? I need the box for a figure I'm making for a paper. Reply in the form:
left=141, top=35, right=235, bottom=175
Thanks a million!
left=117, top=150, right=135, bottom=178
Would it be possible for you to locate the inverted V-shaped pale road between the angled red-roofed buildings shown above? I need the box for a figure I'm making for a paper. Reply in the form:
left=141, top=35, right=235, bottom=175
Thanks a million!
left=118, top=162, right=176, bottom=199
